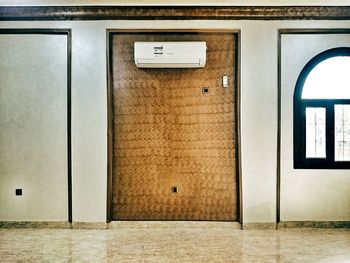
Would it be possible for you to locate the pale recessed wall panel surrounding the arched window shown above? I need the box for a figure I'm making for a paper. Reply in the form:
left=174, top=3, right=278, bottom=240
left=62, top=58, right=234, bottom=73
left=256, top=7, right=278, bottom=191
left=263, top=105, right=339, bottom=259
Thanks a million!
left=281, top=34, right=350, bottom=221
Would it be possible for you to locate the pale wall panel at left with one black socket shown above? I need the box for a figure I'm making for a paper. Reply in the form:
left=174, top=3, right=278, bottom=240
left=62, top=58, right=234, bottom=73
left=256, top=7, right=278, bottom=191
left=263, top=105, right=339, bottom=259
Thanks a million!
left=0, top=34, right=68, bottom=221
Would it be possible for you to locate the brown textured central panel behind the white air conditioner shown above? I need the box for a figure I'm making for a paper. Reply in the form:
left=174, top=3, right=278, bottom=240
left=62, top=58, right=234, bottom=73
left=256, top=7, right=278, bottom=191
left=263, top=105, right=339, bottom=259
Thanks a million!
left=109, top=32, right=239, bottom=221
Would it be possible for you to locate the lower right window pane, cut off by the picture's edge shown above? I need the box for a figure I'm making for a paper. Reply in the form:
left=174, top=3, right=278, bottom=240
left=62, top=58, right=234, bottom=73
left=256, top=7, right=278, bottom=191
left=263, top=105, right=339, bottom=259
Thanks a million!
left=334, top=105, right=350, bottom=161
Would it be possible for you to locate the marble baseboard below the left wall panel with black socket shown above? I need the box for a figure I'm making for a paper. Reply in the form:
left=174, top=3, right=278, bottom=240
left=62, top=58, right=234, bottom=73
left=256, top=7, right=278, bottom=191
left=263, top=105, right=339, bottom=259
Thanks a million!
left=0, top=221, right=71, bottom=229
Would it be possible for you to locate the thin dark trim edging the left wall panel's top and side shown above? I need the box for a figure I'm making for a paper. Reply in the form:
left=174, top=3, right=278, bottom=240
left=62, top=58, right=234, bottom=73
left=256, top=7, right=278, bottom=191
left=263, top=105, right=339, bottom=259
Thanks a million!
left=0, top=28, right=72, bottom=223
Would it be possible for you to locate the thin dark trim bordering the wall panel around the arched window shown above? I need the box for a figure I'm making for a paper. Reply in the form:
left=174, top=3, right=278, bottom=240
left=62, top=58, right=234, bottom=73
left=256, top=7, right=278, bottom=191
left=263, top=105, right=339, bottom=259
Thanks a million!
left=276, top=28, right=350, bottom=225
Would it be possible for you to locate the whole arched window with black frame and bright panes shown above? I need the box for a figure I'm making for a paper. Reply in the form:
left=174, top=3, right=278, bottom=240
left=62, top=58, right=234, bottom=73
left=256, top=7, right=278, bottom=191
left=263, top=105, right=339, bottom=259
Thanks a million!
left=293, top=47, right=350, bottom=169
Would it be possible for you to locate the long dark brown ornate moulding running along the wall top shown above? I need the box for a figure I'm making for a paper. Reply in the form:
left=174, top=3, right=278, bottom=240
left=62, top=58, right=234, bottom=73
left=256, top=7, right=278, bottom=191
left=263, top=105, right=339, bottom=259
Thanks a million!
left=0, top=6, right=350, bottom=21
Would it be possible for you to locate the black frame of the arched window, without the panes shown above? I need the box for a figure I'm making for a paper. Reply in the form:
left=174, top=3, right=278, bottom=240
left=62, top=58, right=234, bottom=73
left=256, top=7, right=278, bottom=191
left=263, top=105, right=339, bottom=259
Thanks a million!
left=293, top=47, right=350, bottom=169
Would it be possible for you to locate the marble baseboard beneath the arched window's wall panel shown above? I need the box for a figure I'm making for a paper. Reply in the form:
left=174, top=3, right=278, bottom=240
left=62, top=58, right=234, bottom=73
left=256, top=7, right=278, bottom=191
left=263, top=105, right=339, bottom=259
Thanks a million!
left=278, top=221, right=350, bottom=229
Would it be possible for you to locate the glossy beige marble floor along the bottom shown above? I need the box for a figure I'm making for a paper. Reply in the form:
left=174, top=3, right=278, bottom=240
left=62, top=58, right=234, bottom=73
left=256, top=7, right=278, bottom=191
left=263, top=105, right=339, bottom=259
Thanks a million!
left=0, top=228, right=350, bottom=263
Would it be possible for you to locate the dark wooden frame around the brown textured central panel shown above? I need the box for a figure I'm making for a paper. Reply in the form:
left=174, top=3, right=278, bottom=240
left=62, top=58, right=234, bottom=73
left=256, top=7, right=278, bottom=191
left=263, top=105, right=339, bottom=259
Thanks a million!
left=106, top=29, right=243, bottom=226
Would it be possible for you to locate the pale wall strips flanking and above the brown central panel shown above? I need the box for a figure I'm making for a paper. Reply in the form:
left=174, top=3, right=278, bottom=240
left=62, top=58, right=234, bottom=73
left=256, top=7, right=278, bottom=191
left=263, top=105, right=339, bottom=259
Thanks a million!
left=0, top=21, right=350, bottom=223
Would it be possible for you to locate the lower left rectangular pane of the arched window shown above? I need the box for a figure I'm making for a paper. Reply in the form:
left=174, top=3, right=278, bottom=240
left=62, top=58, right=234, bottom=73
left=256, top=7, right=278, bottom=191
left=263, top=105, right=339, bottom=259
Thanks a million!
left=306, top=108, right=326, bottom=158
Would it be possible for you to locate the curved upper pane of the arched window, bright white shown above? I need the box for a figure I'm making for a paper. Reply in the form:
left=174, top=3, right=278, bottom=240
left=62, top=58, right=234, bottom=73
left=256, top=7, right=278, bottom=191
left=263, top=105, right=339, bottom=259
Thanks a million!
left=301, top=56, right=350, bottom=99
